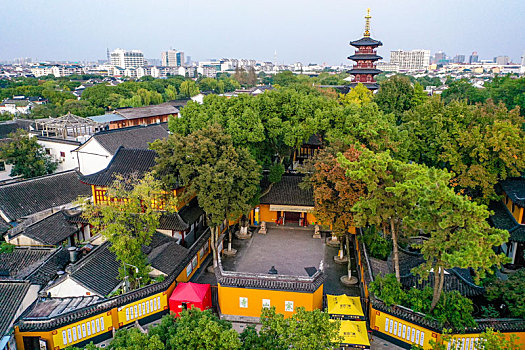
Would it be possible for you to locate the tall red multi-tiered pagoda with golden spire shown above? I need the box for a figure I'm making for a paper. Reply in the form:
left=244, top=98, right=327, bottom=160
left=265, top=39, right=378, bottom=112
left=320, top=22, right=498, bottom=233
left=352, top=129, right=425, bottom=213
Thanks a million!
left=347, top=9, right=383, bottom=90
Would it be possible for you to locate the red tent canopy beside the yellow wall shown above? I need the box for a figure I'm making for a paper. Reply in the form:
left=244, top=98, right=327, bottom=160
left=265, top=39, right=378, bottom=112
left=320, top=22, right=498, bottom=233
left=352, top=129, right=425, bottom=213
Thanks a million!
left=169, top=282, right=211, bottom=315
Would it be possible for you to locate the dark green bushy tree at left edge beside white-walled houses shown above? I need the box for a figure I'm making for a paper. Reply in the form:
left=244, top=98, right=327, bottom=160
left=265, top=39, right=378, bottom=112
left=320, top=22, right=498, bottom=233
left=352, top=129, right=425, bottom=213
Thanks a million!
left=0, top=130, right=58, bottom=179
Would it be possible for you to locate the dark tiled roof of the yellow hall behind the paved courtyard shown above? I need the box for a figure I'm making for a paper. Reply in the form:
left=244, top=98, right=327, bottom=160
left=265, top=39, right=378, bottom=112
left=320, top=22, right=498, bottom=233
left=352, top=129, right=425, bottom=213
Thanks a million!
left=261, top=175, right=314, bottom=207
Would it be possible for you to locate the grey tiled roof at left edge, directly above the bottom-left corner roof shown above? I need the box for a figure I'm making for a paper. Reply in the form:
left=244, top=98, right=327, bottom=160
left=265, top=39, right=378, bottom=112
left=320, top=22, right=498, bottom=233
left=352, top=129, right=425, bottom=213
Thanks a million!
left=0, top=247, right=68, bottom=285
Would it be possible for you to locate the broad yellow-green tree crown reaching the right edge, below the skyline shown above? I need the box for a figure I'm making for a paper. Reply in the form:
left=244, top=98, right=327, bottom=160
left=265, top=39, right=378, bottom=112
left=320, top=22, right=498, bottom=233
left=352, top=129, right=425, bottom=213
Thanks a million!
left=401, top=98, right=525, bottom=201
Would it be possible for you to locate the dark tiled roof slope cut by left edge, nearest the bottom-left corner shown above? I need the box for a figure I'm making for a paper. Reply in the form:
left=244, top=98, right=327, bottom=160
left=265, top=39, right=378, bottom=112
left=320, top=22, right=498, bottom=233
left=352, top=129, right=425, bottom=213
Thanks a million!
left=0, top=281, right=30, bottom=336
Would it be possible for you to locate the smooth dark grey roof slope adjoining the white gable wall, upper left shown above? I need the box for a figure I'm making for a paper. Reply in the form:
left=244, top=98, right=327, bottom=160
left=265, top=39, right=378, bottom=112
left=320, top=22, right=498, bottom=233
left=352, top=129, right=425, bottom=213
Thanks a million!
left=92, top=123, right=168, bottom=154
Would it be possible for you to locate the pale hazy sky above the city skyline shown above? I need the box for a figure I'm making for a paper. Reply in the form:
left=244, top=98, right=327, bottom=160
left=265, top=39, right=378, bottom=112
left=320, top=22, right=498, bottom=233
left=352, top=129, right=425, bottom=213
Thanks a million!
left=0, top=0, right=525, bottom=64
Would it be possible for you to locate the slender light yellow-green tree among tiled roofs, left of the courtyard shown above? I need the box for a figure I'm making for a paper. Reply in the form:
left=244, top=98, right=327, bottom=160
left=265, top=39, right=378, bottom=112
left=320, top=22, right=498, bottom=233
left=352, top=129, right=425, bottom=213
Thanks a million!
left=80, top=174, right=170, bottom=289
